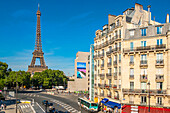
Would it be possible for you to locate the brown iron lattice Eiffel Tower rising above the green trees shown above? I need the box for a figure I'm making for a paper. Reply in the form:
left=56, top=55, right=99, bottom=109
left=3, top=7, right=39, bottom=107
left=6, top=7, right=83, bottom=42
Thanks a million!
left=27, top=4, right=48, bottom=74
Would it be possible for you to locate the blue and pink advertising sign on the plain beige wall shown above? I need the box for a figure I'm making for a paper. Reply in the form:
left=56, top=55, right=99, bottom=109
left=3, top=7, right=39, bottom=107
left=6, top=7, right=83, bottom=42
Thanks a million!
left=77, top=62, right=86, bottom=78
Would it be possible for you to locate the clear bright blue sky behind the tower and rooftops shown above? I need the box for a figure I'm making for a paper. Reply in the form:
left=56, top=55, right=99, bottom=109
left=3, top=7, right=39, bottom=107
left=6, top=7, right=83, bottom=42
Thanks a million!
left=0, top=0, right=170, bottom=76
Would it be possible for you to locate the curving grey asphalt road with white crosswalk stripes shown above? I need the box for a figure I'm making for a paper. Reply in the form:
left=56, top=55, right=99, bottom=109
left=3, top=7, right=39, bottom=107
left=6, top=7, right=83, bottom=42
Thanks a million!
left=18, top=91, right=88, bottom=113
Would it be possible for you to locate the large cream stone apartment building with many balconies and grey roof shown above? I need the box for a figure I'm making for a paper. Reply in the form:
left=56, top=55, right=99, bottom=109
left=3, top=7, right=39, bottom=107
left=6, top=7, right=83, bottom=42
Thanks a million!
left=94, top=3, right=170, bottom=107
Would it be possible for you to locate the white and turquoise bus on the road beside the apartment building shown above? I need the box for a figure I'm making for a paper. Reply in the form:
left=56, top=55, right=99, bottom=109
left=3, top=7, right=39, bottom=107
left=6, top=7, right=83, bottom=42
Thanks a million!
left=78, top=97, right=98, bottom=112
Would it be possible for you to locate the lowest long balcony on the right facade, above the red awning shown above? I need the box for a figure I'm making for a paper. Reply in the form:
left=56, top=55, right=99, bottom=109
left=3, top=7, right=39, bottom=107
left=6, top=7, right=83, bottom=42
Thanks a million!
left=122, top=89, right=166, bottom=95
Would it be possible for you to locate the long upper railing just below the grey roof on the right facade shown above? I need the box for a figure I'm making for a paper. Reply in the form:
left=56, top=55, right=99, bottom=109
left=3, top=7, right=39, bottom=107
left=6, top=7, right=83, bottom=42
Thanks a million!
left=123, top=44, right=166, bottom=53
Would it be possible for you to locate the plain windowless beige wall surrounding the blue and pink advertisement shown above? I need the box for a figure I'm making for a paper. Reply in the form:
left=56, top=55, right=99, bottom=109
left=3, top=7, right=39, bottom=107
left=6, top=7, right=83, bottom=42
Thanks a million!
left=67, top=52, right=89, bottom=92
